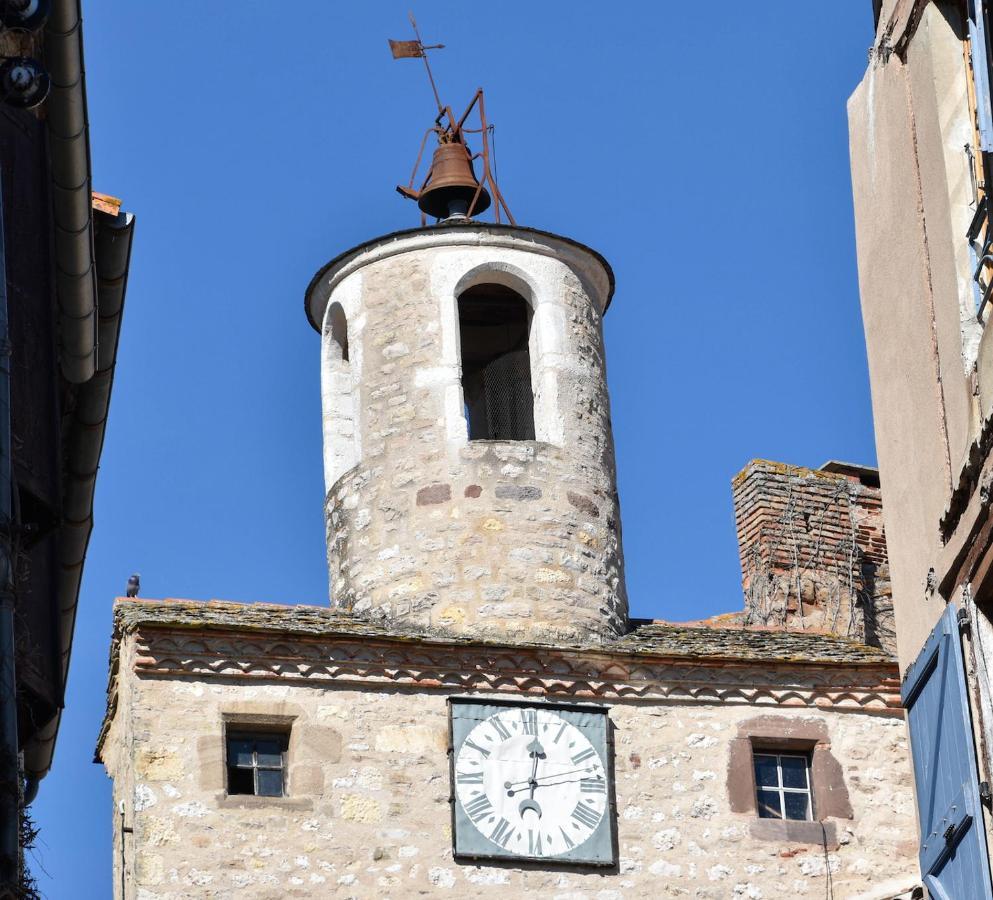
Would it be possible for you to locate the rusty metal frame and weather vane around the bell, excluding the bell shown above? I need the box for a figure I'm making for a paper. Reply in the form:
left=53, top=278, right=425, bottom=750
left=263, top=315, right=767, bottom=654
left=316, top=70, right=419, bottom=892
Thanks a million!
left=389, top=13, right=517, bottom=226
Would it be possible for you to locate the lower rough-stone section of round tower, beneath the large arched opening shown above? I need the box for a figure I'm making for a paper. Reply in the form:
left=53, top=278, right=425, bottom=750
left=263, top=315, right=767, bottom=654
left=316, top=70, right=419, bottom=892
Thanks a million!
left=328, top=441, right=625, bottom=639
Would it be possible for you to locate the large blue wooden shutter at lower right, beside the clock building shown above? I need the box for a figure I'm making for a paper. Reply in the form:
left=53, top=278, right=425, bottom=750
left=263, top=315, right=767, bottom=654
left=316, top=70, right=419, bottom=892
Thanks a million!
left=903, top=603, right=993, bottom=900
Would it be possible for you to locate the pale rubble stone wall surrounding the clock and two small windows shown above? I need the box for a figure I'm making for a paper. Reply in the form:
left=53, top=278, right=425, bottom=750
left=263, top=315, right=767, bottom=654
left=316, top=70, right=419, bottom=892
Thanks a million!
left=104, top=656, right=917, bottom=900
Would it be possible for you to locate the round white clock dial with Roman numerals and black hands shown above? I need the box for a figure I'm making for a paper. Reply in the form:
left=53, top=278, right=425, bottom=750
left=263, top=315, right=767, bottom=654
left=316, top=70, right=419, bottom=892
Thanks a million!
left=455, top=707, right=607, bottom=857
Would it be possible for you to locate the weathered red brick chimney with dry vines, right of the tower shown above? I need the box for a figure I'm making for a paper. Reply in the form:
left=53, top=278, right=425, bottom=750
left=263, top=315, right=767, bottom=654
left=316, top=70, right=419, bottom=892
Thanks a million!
left=732, top=459, right=895, bottom=650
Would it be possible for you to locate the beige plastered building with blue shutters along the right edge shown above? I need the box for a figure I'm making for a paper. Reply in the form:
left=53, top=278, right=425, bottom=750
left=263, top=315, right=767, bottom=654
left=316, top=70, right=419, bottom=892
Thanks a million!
left=848, top=0, right=993, bottom=898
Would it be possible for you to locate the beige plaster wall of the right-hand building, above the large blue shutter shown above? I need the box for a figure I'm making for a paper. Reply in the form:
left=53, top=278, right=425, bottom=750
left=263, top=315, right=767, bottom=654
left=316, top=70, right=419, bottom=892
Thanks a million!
left=848, top=3, right=978, bottom=668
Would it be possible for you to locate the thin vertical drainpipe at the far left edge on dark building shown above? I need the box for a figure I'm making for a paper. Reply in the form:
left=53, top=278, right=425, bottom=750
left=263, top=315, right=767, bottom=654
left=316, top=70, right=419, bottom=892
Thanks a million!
left=0, top=172, right=21, bottom=885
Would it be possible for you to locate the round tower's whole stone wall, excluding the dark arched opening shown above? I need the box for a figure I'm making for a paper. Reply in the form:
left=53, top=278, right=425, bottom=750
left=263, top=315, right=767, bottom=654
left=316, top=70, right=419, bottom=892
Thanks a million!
left=324, top=232, right=627, bottom=640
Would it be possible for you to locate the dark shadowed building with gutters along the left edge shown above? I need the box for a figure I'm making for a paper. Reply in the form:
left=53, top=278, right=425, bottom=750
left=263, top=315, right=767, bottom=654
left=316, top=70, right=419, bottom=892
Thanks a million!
left=0, top=0, right=134, bottom=898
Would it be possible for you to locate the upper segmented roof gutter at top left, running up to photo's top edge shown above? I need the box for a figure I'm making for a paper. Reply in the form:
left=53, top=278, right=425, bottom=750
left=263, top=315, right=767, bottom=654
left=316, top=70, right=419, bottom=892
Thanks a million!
left=45, top=0, right=97, bottom=384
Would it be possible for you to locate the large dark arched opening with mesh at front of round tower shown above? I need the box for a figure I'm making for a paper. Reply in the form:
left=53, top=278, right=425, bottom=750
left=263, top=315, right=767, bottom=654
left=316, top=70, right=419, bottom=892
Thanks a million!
left=459, top=284, right=534, bottom=441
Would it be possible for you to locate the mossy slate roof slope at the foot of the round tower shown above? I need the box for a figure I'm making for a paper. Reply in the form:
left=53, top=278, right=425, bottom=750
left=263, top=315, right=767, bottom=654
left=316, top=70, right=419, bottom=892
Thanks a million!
left=114, top=598, right=896, bottom=666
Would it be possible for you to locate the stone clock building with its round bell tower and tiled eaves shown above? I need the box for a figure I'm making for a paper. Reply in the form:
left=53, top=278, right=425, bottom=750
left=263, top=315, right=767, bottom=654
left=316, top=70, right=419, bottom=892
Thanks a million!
left=97, top=219, right=919, bottom=900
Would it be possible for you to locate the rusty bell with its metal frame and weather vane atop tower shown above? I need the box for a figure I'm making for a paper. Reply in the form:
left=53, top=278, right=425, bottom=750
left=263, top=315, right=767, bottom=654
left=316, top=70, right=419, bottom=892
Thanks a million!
left=389, top=13, right=517, bottom=225
